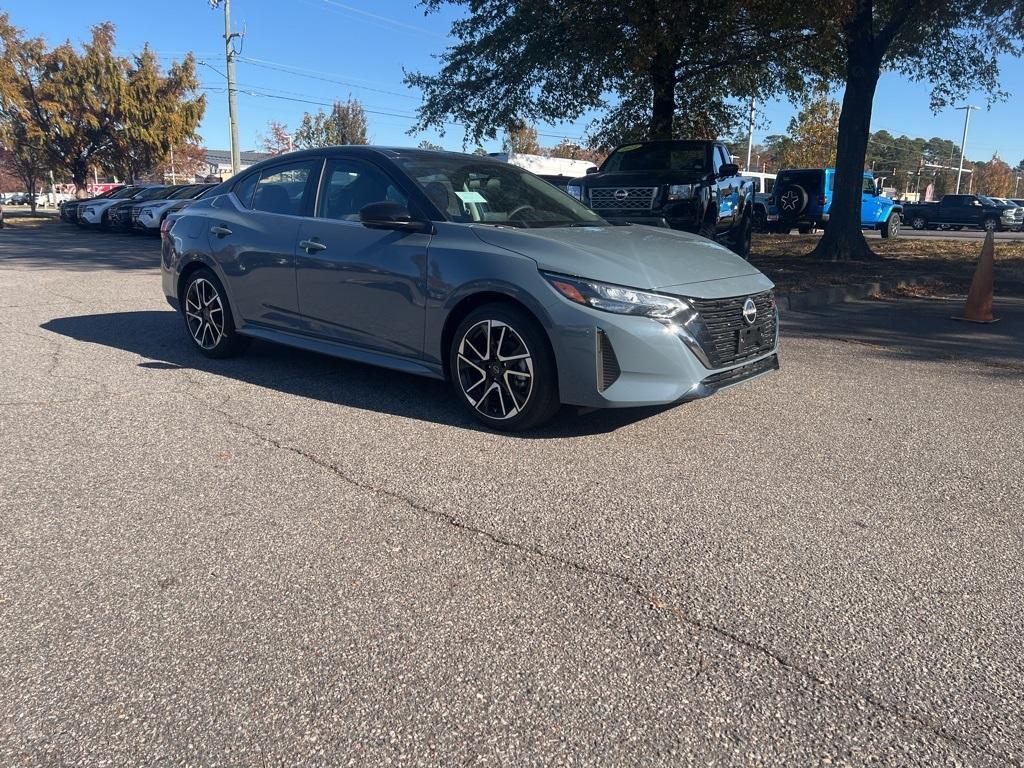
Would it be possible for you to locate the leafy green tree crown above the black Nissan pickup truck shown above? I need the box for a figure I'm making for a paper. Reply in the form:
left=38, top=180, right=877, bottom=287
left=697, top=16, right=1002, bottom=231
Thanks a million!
left=406, top=0, right=809, bottom=145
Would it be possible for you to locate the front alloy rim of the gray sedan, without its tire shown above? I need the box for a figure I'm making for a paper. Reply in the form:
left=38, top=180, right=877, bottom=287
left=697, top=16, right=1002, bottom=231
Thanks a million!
left=457, top=319, right=534, bottom=421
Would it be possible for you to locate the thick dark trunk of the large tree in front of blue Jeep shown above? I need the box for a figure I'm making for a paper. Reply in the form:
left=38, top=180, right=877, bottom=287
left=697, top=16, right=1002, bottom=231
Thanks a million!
left=812, top=3, right=882, bottom=261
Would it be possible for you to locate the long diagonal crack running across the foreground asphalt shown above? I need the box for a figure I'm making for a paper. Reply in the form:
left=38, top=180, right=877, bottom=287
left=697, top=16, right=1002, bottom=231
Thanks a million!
left=183, top=392, right=1024, bottom=766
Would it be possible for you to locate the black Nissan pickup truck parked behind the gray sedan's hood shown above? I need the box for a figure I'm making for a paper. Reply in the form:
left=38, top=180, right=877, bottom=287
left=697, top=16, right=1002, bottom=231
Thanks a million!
left=566, top=140, right=755, bottom=258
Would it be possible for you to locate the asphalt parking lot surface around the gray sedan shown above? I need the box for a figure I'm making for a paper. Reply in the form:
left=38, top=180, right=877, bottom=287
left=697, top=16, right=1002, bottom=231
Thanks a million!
left=6, top=226, right=1024, bottom=766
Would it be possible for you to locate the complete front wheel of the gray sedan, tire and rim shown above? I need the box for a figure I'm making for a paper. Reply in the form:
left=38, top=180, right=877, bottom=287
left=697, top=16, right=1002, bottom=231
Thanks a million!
left=449, top=303, right=561, bottom=432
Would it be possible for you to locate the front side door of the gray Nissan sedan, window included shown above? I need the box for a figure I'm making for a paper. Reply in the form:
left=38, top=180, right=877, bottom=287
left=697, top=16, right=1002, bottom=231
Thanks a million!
left=296, top=157, right=430, bottom=357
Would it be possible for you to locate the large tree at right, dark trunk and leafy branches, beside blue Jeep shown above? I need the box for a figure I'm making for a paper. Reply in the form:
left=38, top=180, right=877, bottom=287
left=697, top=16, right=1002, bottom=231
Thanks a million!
left=798, top=0, right=1024, bottom=260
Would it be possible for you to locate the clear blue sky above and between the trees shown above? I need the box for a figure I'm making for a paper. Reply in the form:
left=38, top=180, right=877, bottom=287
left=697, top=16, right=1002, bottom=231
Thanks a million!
left=3, top=0, right=1024, bottom=165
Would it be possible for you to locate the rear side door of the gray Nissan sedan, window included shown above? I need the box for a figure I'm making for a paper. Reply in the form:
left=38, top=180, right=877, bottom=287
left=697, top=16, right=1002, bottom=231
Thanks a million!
left=207, top=157, right=324, bottom=331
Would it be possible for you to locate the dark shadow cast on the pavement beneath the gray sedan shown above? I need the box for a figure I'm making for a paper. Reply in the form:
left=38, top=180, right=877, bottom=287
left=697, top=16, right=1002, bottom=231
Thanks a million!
left=41, top=310, right=670, bottom=438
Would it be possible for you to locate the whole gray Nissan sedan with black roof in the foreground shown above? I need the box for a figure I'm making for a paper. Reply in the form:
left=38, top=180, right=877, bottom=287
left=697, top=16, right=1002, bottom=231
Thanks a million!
left=161, top=146, right=778, bottom=430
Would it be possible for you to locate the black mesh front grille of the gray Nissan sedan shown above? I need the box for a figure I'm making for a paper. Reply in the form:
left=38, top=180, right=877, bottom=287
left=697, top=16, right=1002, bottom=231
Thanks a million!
left=687, top=291, right=776, bottom=368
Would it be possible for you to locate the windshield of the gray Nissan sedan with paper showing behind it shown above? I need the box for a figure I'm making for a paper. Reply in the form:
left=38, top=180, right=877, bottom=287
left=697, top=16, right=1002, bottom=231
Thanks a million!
left=396, top=155, right=605, bottom=227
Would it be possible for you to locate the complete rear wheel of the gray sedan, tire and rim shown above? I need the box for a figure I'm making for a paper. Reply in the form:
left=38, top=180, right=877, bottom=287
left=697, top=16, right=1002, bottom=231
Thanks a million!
left=180, top=267, right=249, bottom=358
